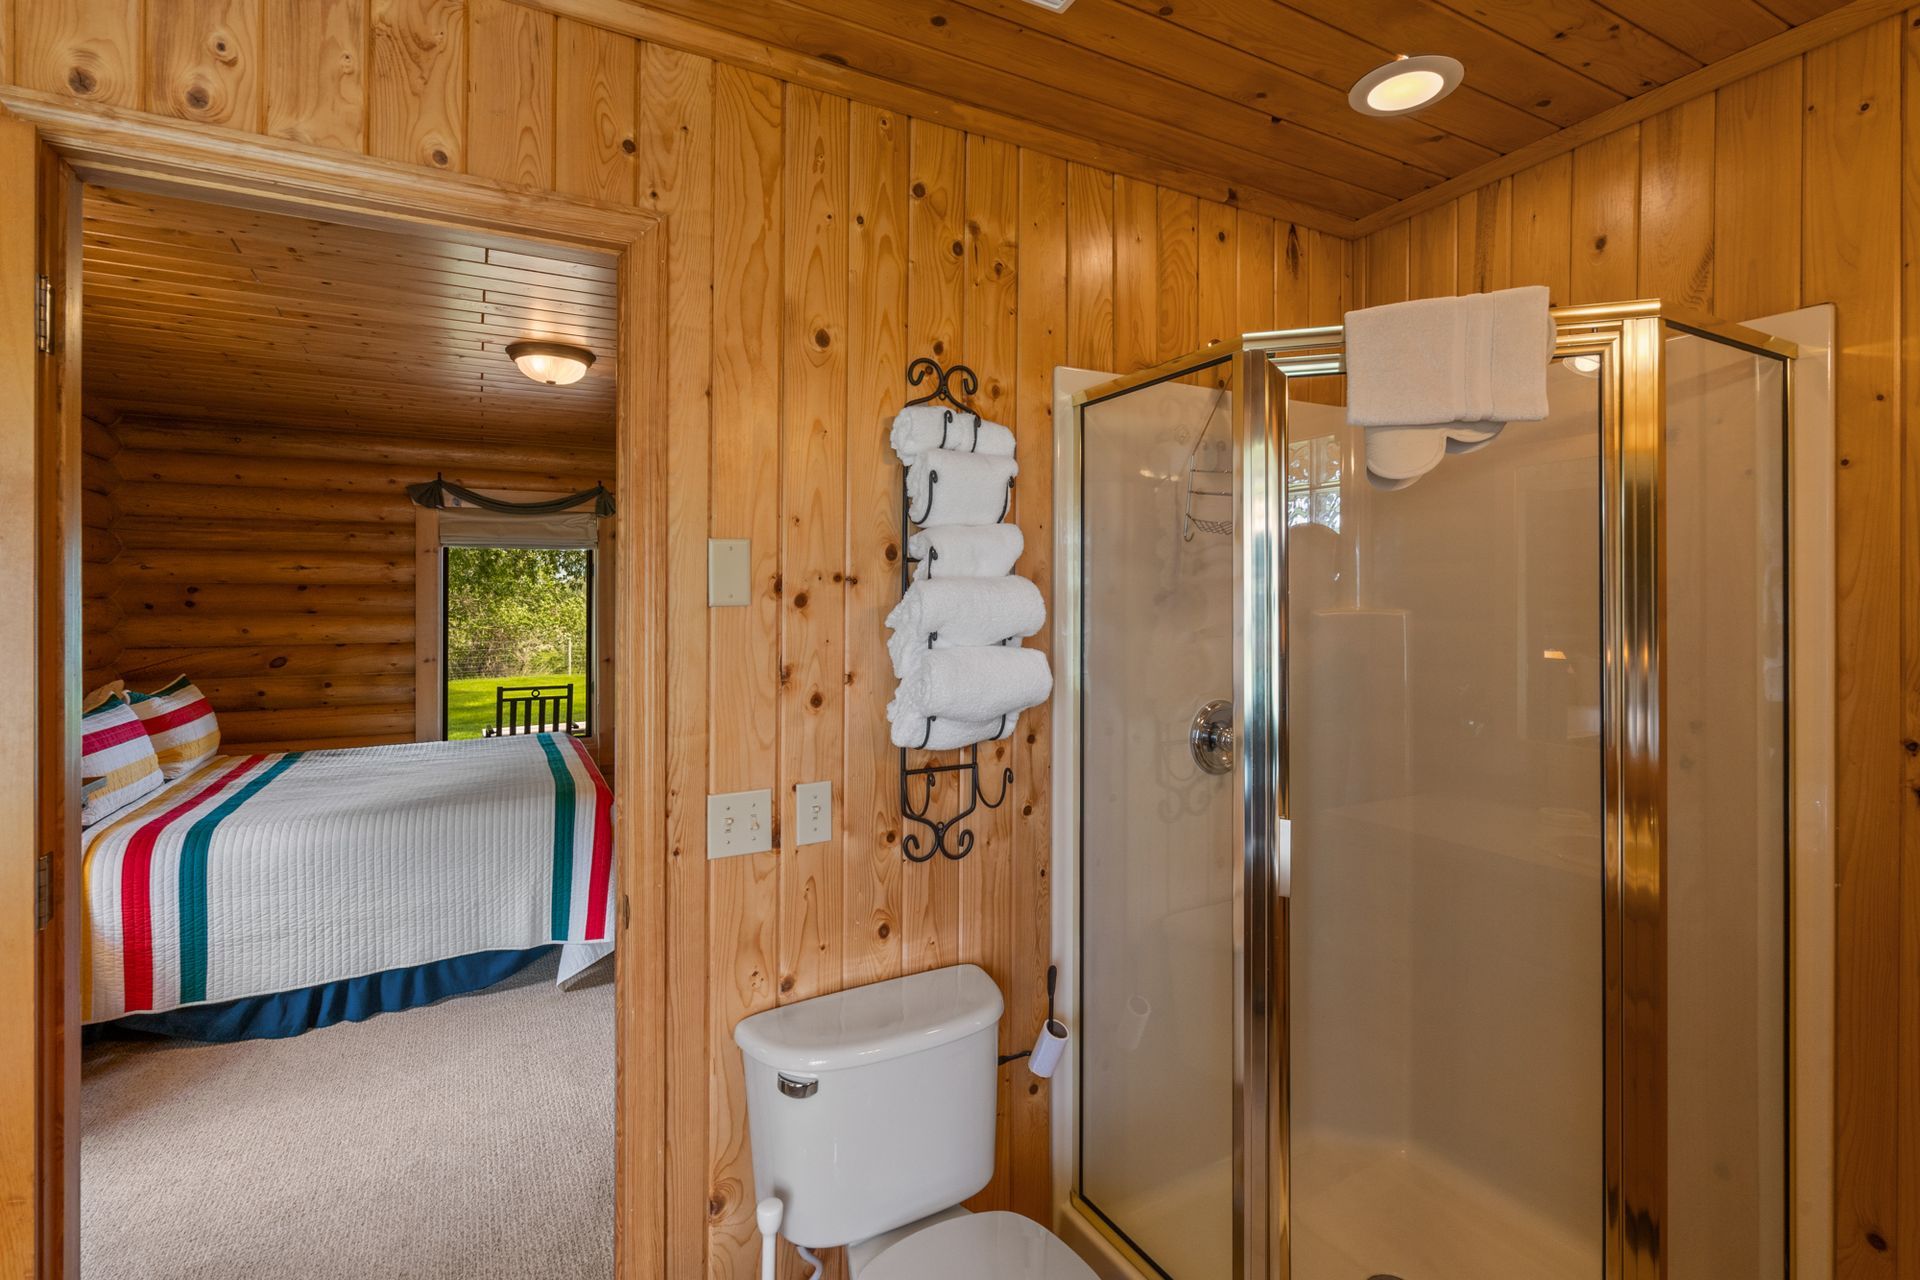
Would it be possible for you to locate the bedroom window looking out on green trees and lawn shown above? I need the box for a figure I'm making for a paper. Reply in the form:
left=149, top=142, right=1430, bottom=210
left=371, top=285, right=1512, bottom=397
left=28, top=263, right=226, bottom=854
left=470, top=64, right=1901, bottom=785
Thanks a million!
left=442, top=547, right=593, bottom=739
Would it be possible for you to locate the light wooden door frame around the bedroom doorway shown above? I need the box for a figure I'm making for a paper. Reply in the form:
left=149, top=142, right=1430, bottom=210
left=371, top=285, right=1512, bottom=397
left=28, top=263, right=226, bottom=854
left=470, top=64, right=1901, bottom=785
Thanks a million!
left=0, top=88, right=668, bottom=1280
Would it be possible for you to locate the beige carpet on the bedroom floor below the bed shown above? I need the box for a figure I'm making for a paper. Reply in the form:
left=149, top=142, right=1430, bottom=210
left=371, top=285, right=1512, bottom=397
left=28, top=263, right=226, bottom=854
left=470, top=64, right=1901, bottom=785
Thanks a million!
left=81, top=958, right=614, bottom=1280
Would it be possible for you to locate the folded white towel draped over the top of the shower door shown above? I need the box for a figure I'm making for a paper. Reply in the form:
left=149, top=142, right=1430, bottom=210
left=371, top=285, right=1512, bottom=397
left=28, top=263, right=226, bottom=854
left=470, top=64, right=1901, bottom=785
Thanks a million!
left=1346, top=286, right=1553, bottom=426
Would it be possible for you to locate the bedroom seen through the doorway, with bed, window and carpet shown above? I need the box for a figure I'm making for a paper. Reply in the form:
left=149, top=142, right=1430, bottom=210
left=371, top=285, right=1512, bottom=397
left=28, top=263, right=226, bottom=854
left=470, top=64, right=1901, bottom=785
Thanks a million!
left=79, top=184, right=624, bottom=1280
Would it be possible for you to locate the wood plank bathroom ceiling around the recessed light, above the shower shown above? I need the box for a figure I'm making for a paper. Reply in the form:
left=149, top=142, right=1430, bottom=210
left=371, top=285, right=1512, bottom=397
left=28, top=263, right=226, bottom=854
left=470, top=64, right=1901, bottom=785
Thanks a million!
left=629, top=0, right=1847, bottom=219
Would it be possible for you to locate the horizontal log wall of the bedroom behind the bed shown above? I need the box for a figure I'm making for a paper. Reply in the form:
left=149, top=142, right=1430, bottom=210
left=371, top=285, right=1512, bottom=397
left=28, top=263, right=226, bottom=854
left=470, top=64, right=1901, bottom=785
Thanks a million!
left=83, top=418, right=612, bottom=750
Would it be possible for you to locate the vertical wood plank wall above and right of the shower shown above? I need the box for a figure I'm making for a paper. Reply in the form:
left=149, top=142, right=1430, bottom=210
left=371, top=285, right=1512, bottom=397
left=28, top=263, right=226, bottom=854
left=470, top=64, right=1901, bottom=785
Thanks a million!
left=1357, top=22, right=1920, bottom=1280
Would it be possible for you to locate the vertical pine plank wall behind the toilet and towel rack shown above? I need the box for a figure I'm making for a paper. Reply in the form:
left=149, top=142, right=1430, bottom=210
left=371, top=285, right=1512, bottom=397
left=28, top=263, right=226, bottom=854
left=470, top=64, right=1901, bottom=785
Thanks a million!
left=0, top=0, right=1350, bottom=1276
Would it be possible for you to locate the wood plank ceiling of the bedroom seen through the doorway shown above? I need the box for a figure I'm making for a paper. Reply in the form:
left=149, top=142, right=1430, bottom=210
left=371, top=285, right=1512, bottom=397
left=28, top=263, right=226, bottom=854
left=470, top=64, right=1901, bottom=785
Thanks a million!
left=83, top=186, right=616, bottom=447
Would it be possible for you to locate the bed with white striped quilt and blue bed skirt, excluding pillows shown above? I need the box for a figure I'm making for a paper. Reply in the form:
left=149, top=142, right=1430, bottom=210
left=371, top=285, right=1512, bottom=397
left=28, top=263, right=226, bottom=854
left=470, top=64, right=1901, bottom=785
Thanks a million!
left=81, top=733, right=616, bottom=1038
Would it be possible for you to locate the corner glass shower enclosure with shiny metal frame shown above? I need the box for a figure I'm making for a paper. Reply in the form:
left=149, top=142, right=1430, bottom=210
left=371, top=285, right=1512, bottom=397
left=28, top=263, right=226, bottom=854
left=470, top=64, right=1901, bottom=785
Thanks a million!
left=1058, top=303, right=1791, bottom=1280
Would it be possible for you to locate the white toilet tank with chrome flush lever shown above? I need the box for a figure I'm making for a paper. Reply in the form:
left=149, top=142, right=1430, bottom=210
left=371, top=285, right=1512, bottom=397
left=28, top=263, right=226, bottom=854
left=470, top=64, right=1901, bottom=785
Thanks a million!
left=733, top=965, right=1002, bottom=1249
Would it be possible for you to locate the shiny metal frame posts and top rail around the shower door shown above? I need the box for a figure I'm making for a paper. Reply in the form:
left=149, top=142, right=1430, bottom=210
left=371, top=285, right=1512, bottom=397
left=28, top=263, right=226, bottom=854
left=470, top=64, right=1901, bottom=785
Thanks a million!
left=1235, top=301, right=1795, bottom=1280
